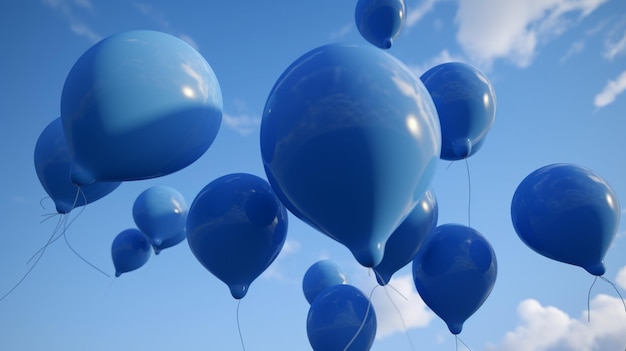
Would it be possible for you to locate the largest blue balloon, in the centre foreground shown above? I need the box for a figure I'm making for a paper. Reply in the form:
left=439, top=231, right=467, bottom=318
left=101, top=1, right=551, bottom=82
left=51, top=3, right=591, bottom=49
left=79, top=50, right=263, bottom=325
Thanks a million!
left=260, top=44, right=441, bottom=267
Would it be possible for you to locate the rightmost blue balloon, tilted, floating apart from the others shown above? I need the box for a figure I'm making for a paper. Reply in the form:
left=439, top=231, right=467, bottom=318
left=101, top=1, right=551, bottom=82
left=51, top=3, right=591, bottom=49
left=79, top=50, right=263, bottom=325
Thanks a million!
left=511, top=163, right=620, bottom=276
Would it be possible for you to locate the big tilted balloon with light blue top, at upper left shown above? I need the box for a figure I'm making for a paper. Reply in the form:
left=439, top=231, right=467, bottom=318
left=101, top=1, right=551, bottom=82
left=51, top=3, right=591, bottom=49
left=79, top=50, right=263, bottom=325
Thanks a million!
left=61, top=30, right=222, bottom=184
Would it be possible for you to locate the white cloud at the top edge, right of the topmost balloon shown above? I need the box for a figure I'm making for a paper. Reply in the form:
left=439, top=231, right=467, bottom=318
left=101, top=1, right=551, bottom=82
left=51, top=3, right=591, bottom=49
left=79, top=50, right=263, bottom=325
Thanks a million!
left=456, top=0, right=606, bottom=67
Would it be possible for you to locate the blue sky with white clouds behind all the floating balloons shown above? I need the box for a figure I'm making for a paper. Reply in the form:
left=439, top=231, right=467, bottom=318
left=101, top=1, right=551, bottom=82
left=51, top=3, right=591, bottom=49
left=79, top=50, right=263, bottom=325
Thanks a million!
left=0, top=0, right=626, bottom=351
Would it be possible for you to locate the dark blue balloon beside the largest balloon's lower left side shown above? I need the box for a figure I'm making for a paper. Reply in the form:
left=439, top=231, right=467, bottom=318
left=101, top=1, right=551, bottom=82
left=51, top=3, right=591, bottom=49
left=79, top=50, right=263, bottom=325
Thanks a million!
left=187, top=173, right=287, bottom=299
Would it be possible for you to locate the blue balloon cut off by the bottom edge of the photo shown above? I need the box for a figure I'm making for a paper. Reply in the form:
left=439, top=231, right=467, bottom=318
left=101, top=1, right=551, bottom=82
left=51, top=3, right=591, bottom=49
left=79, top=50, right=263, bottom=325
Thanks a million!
left=306, top=284, right=377, bottom=351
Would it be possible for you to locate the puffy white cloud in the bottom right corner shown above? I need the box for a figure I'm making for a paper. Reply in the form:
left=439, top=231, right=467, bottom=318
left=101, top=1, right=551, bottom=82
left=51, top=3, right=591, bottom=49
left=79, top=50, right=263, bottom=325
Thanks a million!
left=486, top=295, right=626, bottom=351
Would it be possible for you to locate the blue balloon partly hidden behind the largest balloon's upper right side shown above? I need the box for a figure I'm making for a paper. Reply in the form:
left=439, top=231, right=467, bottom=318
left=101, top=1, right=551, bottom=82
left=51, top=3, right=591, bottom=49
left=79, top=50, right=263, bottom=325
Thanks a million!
left=420, top=62, right=496, bottom=161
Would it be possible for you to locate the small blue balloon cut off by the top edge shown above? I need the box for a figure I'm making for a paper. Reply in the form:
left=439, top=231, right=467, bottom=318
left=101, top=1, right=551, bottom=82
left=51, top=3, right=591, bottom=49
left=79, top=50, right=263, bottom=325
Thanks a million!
left=354, top=0, right=406, bottom=49
